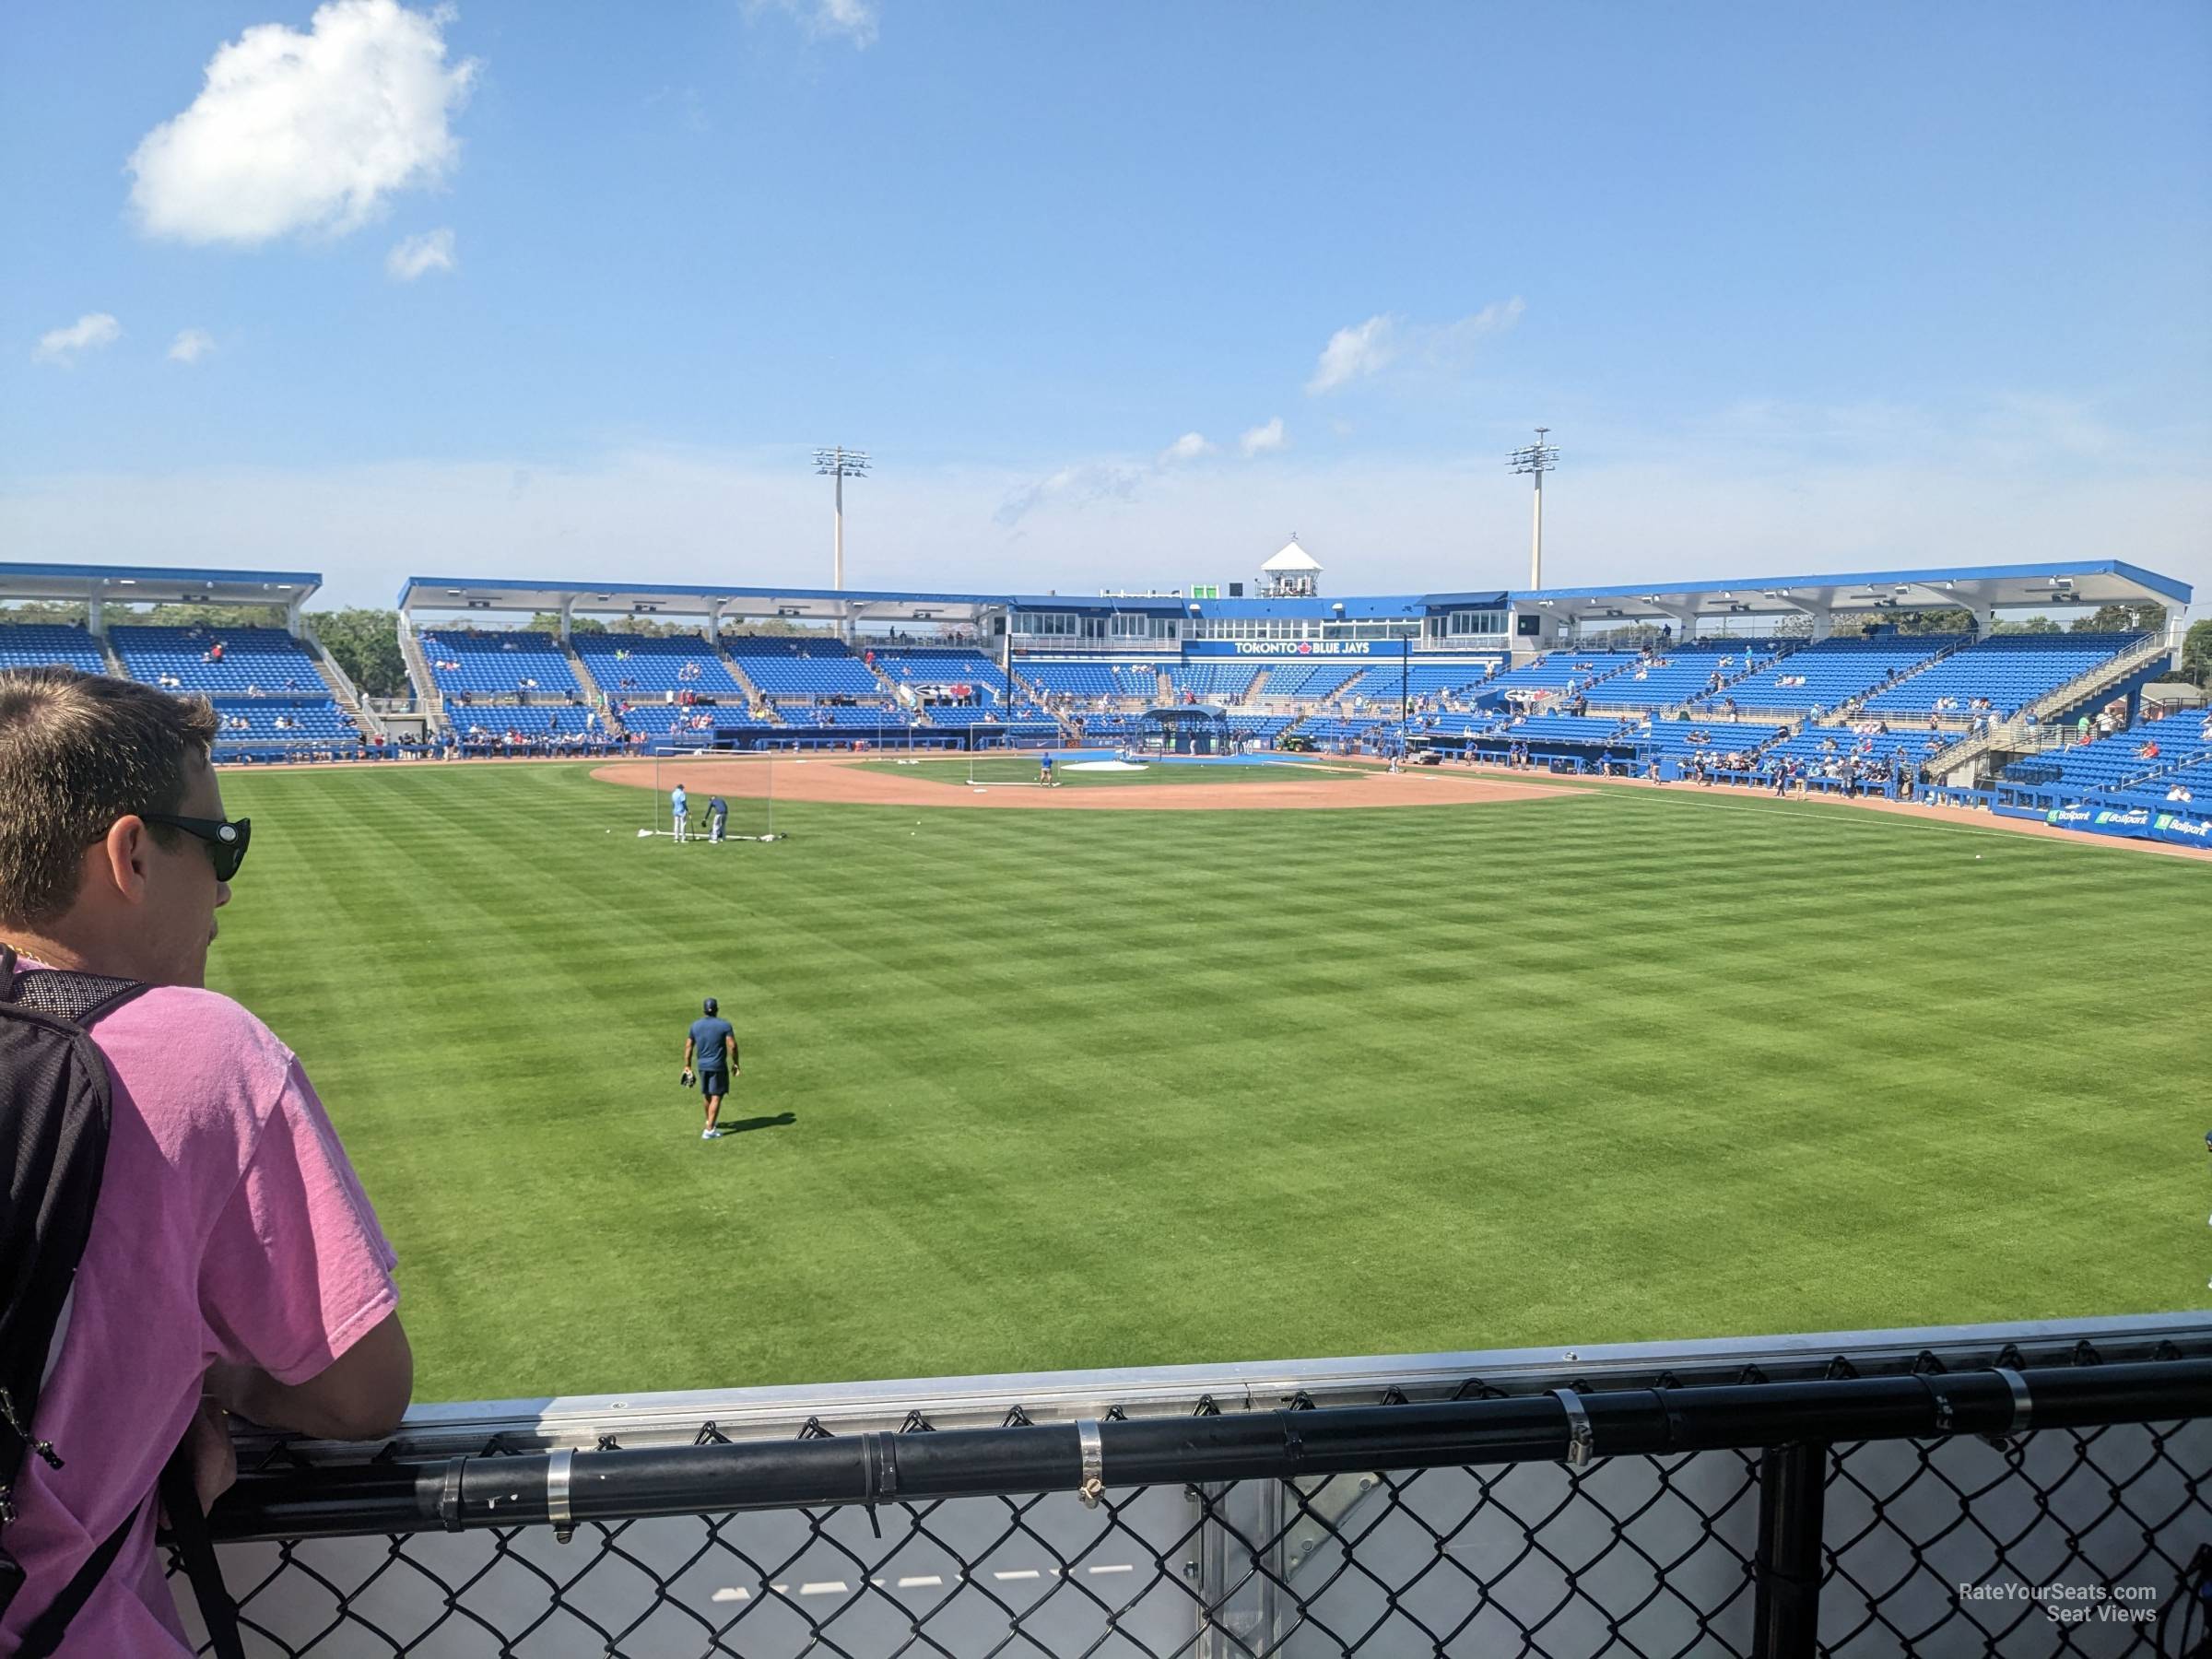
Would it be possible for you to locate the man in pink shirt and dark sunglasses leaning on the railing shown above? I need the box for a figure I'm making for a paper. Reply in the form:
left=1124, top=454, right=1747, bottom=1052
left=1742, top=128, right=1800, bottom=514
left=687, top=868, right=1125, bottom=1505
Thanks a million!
left=0, top=668, right=414, bottom=1659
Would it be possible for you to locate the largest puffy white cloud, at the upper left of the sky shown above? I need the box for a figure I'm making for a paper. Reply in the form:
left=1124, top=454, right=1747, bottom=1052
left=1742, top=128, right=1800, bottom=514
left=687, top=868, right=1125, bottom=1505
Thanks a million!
left=128, top=0, right=476, bottom=248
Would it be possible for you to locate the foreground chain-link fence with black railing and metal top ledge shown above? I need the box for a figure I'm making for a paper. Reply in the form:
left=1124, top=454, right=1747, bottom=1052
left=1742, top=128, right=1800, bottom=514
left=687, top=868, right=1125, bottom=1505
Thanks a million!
left=172, top=1314, right=2212, bottom=1659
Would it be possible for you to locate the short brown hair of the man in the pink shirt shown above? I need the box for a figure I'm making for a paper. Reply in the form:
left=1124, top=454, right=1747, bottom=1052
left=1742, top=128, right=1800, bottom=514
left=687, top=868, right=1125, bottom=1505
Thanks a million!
left=0, top=668, right=217, bottom=927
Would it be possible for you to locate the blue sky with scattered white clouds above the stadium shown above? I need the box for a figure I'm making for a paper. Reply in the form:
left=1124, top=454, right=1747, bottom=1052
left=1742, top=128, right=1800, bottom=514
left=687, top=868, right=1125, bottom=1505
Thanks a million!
left=0, top=0, right=2212, bottom=602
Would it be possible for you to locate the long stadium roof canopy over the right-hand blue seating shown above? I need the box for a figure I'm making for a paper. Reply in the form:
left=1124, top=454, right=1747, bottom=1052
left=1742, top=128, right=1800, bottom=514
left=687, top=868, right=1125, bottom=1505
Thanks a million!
left=1513, top=559, right=2190, bottom=621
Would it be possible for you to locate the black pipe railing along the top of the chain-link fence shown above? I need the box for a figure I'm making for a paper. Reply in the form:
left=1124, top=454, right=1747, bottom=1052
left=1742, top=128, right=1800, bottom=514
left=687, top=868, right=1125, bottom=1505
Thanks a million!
left=210, top=1359, right=2212, bottom=1539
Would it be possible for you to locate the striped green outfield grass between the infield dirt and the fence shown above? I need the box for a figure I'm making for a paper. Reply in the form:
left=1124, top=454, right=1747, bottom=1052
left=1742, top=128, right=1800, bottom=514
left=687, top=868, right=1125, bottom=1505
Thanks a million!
left=199, top=765, right=2212, bottom=1398
